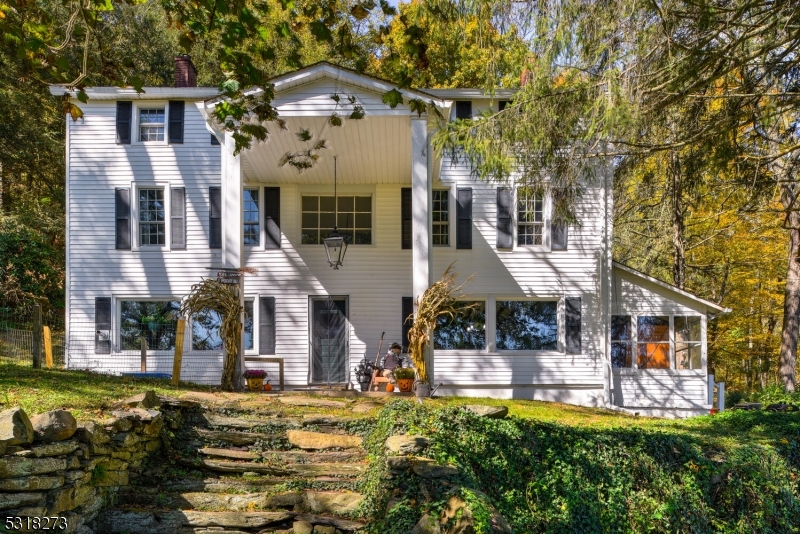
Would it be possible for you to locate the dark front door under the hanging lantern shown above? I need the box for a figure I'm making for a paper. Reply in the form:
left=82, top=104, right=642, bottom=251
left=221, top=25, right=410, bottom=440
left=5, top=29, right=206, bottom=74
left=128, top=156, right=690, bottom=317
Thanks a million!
left=310, top=297, right=350, bottom=384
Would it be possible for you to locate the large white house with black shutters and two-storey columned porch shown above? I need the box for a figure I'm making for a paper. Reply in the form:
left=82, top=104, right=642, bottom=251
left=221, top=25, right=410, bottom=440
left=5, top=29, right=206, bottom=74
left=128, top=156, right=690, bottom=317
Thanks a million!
left=52, top=60, right=725, bottom=414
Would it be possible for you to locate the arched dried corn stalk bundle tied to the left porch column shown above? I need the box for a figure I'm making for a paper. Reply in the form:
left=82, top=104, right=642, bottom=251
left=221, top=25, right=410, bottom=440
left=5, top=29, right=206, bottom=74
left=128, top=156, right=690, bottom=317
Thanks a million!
left=181, top=278, right=244, bottom=391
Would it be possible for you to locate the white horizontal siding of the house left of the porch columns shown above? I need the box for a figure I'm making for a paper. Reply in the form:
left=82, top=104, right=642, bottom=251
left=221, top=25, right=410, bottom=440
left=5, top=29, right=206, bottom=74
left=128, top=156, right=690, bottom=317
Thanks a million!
left=66, top=99, right=222, bottom=384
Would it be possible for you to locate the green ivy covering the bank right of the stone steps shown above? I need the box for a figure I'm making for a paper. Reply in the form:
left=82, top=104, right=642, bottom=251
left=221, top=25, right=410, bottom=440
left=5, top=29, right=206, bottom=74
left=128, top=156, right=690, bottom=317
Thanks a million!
left=365, top=401, right=800, bottom=534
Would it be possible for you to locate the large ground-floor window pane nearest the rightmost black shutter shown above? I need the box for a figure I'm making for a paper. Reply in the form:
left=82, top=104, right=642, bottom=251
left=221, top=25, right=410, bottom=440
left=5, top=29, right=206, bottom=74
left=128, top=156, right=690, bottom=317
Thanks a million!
left=496, top=300, right=558, bottom=350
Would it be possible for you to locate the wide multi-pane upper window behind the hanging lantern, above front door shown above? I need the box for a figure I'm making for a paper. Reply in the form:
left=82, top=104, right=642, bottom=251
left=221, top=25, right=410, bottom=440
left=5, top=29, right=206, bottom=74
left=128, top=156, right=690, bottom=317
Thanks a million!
left=301, top=195, right=372, bottom=245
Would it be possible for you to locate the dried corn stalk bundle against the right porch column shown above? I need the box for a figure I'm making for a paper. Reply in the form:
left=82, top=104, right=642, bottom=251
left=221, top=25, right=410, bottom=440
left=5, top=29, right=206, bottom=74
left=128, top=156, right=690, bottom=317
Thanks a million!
left=408, top=263, right=475, bottom=382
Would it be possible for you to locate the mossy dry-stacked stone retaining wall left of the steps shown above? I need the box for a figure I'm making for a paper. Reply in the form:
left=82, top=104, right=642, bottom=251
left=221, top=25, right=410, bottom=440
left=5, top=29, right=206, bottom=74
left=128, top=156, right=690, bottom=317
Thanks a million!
left=0, top=391, right=188, bottom=534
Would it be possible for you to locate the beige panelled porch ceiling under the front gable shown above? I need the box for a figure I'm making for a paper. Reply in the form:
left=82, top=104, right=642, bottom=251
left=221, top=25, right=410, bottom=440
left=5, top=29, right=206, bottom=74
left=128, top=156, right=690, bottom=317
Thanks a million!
left=242, top=115, right=411, bottom=184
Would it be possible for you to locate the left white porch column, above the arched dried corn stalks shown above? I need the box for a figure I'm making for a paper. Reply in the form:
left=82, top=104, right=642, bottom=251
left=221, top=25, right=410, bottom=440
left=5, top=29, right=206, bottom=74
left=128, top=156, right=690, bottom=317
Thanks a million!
left=221, top=132, right=244, bottom=269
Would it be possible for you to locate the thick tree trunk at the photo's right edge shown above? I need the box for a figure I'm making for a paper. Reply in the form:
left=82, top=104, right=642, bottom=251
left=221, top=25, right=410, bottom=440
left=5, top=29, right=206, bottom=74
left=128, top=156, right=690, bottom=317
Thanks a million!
left=779, top=220, right=800, bottom=391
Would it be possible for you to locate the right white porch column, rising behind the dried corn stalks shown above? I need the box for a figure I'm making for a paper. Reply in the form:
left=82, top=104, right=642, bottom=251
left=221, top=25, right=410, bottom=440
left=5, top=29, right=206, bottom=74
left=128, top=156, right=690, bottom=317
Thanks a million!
left=411, top=115, right=433, bottom=380
